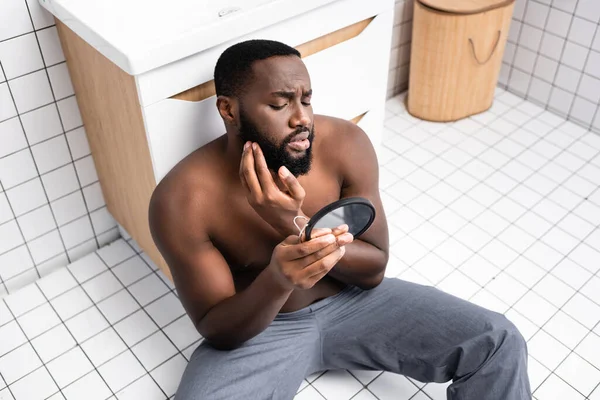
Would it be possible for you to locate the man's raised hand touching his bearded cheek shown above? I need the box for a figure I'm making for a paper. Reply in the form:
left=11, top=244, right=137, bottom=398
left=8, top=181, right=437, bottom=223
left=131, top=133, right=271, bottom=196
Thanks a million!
left=239, top=142, right=306, bottom=236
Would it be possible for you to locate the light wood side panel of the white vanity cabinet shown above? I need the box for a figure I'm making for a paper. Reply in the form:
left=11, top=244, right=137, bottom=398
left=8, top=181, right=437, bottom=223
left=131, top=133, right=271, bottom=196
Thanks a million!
left=56, top=19, right=170, bottom=277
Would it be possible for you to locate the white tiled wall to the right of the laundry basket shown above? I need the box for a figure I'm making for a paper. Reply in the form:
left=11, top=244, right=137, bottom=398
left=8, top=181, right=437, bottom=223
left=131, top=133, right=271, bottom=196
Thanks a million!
left=500, top=0, right=600, bottom=132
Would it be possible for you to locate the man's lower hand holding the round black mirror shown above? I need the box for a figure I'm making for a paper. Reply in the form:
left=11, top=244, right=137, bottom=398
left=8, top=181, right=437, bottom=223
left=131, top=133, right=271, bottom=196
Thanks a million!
left=267, top=226, right=353, bottom=290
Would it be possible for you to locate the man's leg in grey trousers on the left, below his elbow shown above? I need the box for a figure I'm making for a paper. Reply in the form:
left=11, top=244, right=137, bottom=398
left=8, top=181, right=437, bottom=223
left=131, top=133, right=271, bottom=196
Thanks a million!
left=175, top=310, right=320, bottom=400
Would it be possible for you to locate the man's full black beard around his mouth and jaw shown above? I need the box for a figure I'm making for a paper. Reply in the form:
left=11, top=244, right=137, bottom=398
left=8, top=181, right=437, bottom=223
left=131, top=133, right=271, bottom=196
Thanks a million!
left=239, top=109, right=315, bottom=177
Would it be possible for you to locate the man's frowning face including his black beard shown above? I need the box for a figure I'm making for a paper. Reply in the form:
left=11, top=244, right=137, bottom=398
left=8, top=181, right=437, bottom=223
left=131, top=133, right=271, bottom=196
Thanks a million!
left=238, top=56, right=314, bottom=176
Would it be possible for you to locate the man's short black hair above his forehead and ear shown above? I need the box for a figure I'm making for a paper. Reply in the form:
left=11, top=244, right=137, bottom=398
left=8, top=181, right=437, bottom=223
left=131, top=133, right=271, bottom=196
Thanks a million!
left=215, top=40, right=300, bottom=97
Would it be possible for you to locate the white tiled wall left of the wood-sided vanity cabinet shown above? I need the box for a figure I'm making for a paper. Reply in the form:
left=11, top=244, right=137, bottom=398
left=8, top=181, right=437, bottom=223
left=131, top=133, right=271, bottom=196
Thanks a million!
left=0, top=0, right=119, bottom=297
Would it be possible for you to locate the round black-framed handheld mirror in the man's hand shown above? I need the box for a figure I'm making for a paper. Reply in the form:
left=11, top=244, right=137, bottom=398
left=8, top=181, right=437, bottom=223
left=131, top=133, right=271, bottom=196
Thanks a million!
left=304, top=197, right=375, bottom=241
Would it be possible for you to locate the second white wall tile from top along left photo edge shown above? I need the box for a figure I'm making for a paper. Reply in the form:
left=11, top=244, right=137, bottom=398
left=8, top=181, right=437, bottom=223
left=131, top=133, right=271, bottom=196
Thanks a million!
left=0, top=33, right=44, bottom=79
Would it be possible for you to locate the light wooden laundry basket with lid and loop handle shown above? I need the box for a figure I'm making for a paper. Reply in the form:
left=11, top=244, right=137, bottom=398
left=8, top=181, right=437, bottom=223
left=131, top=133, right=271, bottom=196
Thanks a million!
left=408, top=0, right=514, bottom=121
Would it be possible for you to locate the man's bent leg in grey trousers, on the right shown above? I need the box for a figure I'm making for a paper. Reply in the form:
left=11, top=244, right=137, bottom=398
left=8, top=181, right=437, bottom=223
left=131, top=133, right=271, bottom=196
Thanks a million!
left=317, top=279, right=531, bottom=400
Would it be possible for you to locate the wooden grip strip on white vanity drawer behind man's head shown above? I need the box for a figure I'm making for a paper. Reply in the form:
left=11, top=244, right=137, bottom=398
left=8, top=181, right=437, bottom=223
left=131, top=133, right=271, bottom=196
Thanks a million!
left=170, top=17, right=375, bottom=101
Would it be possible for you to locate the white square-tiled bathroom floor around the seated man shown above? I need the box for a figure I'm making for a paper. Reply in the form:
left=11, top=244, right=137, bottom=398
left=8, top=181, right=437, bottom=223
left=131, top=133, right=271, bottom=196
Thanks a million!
left=0, top=89, right=600, bottom=400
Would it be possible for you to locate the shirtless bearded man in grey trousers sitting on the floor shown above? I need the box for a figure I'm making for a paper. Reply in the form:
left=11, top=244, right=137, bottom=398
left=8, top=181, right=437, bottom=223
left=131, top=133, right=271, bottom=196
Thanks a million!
left=149, top=40, right=531, bottom=400
